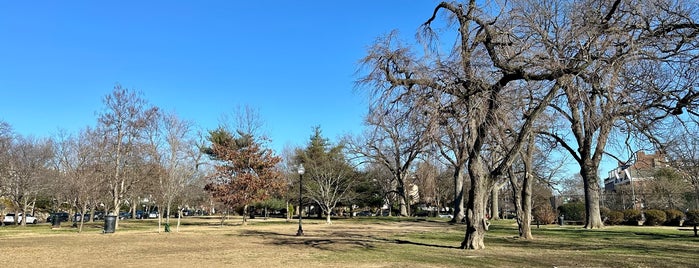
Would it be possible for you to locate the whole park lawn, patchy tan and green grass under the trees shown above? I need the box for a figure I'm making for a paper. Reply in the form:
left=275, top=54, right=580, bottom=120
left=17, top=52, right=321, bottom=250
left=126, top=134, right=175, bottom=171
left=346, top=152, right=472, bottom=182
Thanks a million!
left=0, top=218, right=699, bottom=267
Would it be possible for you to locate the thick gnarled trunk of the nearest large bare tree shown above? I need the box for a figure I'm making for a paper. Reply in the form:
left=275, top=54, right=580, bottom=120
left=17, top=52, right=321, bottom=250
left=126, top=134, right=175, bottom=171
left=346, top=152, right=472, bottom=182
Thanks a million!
left=461, top=159, right=489, bottom=250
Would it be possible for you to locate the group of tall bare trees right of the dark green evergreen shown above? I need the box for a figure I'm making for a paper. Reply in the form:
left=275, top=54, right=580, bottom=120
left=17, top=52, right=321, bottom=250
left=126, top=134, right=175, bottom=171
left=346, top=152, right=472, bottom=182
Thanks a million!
left=356, top=0, right=699, bottom=249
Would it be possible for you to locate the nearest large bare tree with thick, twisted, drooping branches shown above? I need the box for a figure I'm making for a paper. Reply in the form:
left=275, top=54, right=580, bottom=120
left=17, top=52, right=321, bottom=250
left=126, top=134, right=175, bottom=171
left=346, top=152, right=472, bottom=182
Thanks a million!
left=363, top=0, right=584, bottom=249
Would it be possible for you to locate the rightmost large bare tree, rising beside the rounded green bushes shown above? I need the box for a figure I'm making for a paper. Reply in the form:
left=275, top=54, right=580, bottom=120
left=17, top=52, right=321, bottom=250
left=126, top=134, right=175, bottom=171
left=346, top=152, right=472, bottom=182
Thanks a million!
left=541, top=0, right=699, bottom=228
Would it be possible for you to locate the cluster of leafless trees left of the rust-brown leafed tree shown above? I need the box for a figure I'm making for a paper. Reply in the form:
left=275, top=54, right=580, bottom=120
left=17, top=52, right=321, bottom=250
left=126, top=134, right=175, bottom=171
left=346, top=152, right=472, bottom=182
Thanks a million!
left=0, top=84, right=206, bottom=231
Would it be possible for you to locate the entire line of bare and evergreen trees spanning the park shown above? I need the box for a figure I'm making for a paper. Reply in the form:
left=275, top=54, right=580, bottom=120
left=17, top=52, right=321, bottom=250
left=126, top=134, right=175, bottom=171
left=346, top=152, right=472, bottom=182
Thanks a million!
left=0, top=0, right=699, bottom=252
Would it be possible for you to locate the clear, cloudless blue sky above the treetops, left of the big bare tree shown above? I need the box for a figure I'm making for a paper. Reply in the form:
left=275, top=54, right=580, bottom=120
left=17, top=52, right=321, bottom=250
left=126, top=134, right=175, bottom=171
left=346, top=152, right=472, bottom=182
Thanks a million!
left=0, top=0, right=437, bottom=150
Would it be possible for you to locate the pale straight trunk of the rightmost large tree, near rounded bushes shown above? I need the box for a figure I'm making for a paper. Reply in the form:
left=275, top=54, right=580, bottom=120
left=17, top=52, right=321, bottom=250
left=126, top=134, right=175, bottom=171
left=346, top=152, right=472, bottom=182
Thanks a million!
left=580, top=167, right=604, bottom=229
